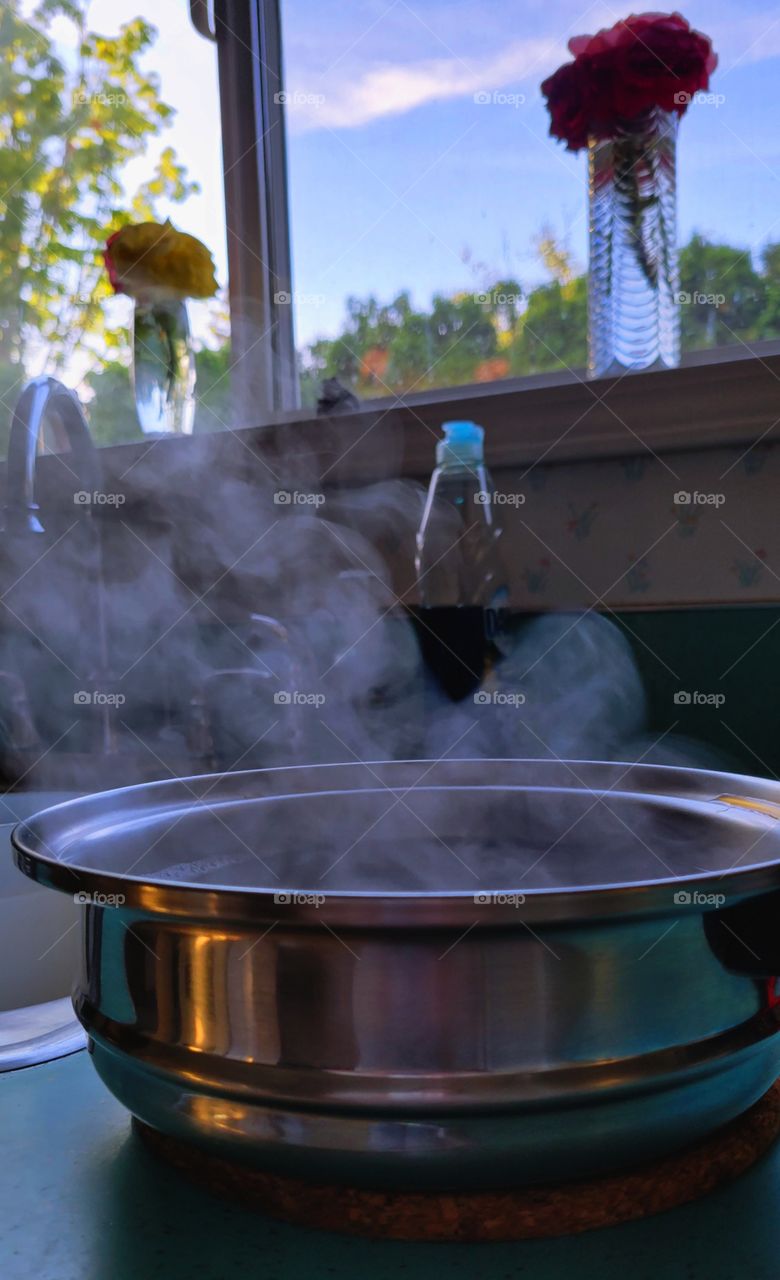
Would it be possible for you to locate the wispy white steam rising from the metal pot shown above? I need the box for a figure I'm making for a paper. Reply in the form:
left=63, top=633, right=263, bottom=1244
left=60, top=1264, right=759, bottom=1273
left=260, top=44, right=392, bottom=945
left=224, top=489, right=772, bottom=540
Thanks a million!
left=10, top=460, right=727, bottom=891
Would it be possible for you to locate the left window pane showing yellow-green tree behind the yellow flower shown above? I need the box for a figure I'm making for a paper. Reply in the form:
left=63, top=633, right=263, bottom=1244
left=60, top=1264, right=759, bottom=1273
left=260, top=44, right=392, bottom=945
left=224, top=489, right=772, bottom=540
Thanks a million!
left=0, top=0, right=229, bottom=443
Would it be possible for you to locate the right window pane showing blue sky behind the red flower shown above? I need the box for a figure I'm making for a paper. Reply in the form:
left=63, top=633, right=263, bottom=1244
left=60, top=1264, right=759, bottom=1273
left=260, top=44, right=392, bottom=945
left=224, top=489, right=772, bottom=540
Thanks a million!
left=282, top=0, right=780, bottom=402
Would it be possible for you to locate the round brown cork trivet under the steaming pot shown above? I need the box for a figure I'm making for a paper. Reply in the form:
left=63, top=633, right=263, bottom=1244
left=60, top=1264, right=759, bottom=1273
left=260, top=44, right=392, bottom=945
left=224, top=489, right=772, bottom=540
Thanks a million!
left=134, top=1080, right=780, bottom=1240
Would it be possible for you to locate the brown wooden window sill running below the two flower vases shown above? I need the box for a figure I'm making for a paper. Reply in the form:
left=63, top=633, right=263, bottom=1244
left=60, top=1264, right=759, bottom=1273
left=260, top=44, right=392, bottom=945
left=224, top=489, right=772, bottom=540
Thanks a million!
left=22, top=340, right=780, bottom=494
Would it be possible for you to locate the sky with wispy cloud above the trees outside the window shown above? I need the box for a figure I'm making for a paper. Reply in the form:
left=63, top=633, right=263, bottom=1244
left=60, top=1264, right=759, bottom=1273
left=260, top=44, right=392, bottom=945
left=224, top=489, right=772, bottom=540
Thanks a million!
left=40, top=0, right=780, bottom=343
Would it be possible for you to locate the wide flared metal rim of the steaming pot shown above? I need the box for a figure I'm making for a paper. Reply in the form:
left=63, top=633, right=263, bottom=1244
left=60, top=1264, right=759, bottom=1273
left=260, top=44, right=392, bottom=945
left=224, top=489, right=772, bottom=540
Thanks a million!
left=12, top=759, right=780, bottom=929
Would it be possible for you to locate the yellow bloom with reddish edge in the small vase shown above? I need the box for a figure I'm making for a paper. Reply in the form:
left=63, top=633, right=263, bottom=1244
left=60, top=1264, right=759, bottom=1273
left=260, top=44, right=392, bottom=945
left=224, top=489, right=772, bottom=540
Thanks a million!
left=104, top=220, right=216, bottom=301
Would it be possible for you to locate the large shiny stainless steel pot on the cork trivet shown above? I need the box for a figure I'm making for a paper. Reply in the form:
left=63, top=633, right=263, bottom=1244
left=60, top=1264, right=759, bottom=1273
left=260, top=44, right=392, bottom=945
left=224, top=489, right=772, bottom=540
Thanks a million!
left=13, top=760, right=780, bottom=1188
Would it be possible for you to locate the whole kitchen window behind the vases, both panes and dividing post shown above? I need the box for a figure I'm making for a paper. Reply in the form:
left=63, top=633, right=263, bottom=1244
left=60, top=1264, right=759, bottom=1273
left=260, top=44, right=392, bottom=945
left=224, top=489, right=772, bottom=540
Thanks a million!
left=0, top=0, right=780, bottom=455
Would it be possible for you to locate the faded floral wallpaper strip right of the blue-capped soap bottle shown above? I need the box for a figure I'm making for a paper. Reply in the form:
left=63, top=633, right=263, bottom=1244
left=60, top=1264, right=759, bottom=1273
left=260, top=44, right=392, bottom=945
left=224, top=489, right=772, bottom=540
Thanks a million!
left=496, top=443, right=780, bottom=608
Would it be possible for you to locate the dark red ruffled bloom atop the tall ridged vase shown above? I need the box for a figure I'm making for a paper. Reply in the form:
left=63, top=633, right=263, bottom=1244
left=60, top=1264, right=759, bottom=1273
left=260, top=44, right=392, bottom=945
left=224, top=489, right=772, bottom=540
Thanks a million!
left=542, top=13, right=717, bottom=151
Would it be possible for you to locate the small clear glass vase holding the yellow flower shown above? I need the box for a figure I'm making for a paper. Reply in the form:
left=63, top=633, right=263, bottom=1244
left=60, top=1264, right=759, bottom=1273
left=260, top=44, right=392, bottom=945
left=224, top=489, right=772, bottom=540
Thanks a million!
left=133, top=300, right=196, bottom=435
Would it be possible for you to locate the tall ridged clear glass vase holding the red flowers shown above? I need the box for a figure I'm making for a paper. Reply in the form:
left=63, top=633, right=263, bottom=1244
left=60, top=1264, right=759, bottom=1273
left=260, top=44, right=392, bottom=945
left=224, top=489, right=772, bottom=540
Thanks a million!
left=588, top=109, right=680, bottom=378
